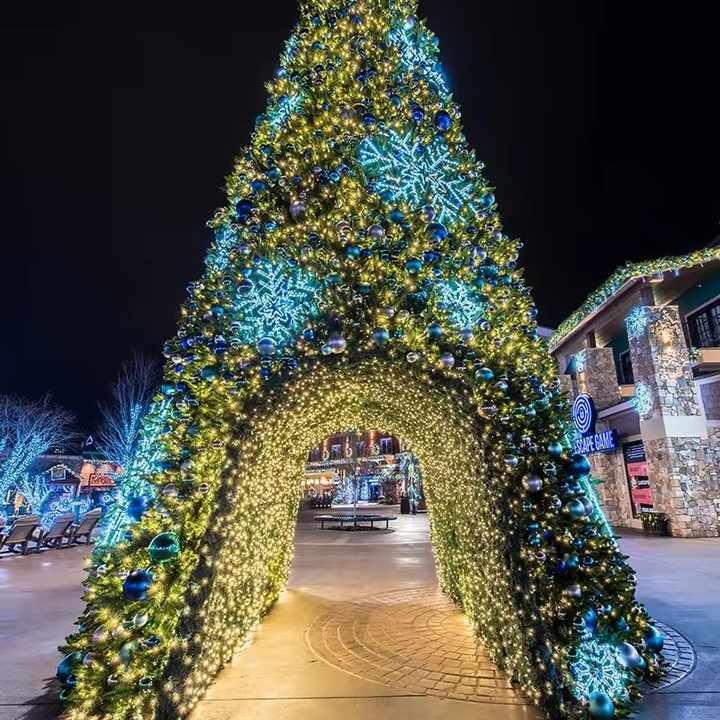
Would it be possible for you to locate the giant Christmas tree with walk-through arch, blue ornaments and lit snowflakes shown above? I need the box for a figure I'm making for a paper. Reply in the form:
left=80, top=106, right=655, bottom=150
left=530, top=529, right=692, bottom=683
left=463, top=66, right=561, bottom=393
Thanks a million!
left=58, top=0, right=662, bottom=720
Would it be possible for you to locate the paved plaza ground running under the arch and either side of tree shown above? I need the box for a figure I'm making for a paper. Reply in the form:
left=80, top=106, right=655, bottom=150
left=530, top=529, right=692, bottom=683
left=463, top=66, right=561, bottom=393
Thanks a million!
left=0, top=514, right=720, bottom=720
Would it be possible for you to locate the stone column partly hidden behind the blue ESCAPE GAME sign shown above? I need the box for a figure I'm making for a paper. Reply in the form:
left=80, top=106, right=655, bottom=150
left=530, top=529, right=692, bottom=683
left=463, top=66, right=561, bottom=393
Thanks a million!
left=575, top=347, right=629, bottom=526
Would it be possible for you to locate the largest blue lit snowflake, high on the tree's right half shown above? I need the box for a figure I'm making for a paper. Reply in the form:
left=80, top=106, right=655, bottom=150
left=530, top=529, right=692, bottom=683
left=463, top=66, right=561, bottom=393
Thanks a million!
left=358, top=130, right=474, bottom=223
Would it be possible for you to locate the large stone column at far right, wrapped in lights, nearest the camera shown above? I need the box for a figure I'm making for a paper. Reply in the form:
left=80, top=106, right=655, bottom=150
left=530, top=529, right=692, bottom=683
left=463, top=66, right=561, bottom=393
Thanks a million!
left=626, top=306, right=719, bottom=537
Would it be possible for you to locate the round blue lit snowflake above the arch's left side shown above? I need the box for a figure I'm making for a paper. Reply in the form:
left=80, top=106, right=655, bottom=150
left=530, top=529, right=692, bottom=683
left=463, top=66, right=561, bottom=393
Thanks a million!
left=232, top=260, right=320, bottom=348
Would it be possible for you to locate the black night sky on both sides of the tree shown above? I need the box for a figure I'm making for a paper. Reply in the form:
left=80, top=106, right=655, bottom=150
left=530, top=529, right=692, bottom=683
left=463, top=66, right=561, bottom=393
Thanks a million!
left=0, top=0, right=720, bottom=430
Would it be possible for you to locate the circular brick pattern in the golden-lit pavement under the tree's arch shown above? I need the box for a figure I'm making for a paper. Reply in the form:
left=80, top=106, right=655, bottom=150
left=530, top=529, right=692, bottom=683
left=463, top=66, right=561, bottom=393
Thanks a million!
left=306, top=587, right=529, bottom=705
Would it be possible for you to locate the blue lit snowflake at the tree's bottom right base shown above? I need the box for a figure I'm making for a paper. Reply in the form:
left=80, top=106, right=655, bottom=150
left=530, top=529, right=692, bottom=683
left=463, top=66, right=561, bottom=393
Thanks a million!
left=570, top=638, right=632, bottom=700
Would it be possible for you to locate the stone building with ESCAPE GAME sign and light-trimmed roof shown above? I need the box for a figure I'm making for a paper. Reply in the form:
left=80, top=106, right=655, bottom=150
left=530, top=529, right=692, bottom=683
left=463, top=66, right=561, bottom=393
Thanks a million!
left=549, top=241, right=720, bottom=537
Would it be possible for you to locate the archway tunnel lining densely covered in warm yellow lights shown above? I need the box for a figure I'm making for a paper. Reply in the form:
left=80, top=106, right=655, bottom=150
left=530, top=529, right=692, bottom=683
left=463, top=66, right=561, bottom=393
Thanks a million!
left=169, top=359, right=528, bottom=709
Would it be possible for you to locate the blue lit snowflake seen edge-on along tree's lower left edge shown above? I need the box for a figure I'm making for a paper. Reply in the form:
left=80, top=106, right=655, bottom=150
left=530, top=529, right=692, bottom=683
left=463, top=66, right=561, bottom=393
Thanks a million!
left=95, top=398, right=173, bottom=553
